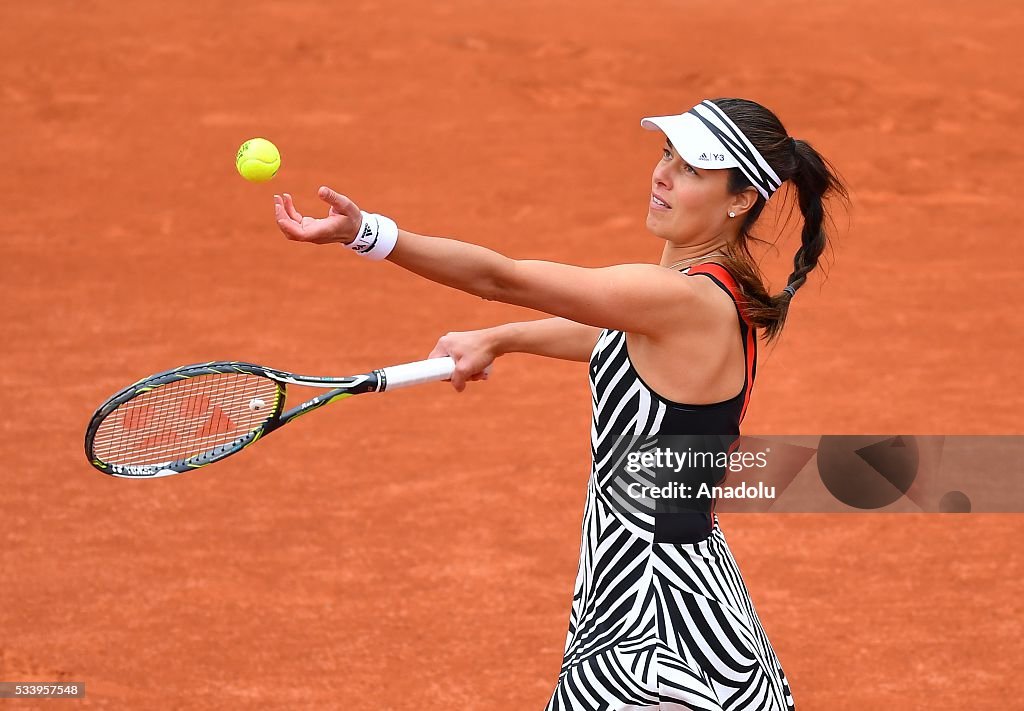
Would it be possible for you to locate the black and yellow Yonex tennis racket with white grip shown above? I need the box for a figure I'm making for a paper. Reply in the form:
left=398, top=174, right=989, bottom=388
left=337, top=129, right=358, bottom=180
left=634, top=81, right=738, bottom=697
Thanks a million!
left=85, top=357, right=455, bottom=478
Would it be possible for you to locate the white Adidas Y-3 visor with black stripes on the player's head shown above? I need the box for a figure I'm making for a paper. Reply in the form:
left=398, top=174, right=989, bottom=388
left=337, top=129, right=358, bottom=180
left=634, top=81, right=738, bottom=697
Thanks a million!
left=640, top=99, right=782, bottom=200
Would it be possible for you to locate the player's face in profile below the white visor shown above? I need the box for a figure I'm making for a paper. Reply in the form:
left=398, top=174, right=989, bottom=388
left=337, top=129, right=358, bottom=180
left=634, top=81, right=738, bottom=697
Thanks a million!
left=647, top=142, right=733, bottom=245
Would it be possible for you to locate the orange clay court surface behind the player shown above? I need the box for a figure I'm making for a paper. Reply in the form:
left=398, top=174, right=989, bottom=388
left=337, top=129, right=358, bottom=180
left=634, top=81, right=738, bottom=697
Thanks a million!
left=0, top=0, right=1024, bottom=711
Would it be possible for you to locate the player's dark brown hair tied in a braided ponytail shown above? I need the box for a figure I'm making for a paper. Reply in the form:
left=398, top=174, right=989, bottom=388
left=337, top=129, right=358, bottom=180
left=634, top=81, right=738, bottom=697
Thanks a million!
left=712, top=98, right=850, bottom=341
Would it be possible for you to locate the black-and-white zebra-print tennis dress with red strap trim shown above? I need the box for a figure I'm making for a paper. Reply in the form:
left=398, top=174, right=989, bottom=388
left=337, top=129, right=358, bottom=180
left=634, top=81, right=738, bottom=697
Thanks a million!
left=547, top=263, right=794, bottom=711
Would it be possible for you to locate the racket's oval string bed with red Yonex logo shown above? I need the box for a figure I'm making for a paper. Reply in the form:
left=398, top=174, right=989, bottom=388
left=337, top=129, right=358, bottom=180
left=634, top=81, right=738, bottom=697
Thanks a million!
left=93, top=373, right=282, bottom=466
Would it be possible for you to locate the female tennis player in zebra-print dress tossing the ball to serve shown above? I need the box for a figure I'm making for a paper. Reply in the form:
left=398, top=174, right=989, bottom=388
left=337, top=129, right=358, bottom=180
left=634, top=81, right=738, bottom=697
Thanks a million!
left=274, top=98, right=848, bottom=711
